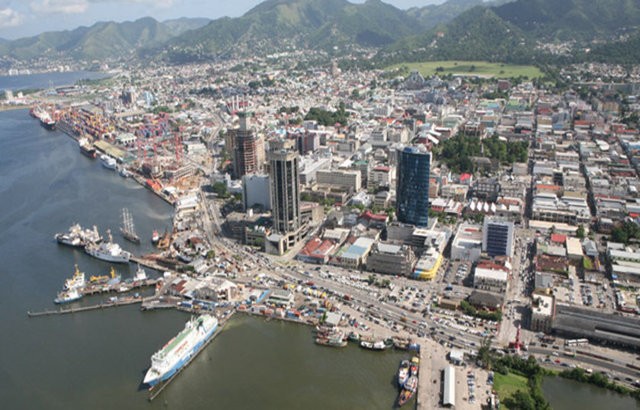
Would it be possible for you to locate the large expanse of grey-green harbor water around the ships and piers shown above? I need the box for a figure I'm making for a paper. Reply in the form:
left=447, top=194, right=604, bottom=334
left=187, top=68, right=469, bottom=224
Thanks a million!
left=0, top=107, right=408, bottom=409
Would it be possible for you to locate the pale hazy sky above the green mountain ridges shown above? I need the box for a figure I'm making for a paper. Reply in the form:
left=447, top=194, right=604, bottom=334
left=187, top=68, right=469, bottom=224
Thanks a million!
left=0, top=0, right=444, bottom=39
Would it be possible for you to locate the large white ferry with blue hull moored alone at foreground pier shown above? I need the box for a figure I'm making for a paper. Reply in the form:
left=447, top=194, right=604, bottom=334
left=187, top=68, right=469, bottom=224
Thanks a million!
left=143, top=315, right=218, bottom=388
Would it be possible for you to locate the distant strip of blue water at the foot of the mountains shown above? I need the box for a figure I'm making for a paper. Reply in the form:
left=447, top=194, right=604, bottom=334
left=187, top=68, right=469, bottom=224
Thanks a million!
left=0, top=71, right=109, bottom=91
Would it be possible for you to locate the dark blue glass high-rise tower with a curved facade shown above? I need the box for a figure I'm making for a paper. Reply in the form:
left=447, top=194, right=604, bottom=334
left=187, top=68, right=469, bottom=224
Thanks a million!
left=396, top=146, right=431, bottom=226
